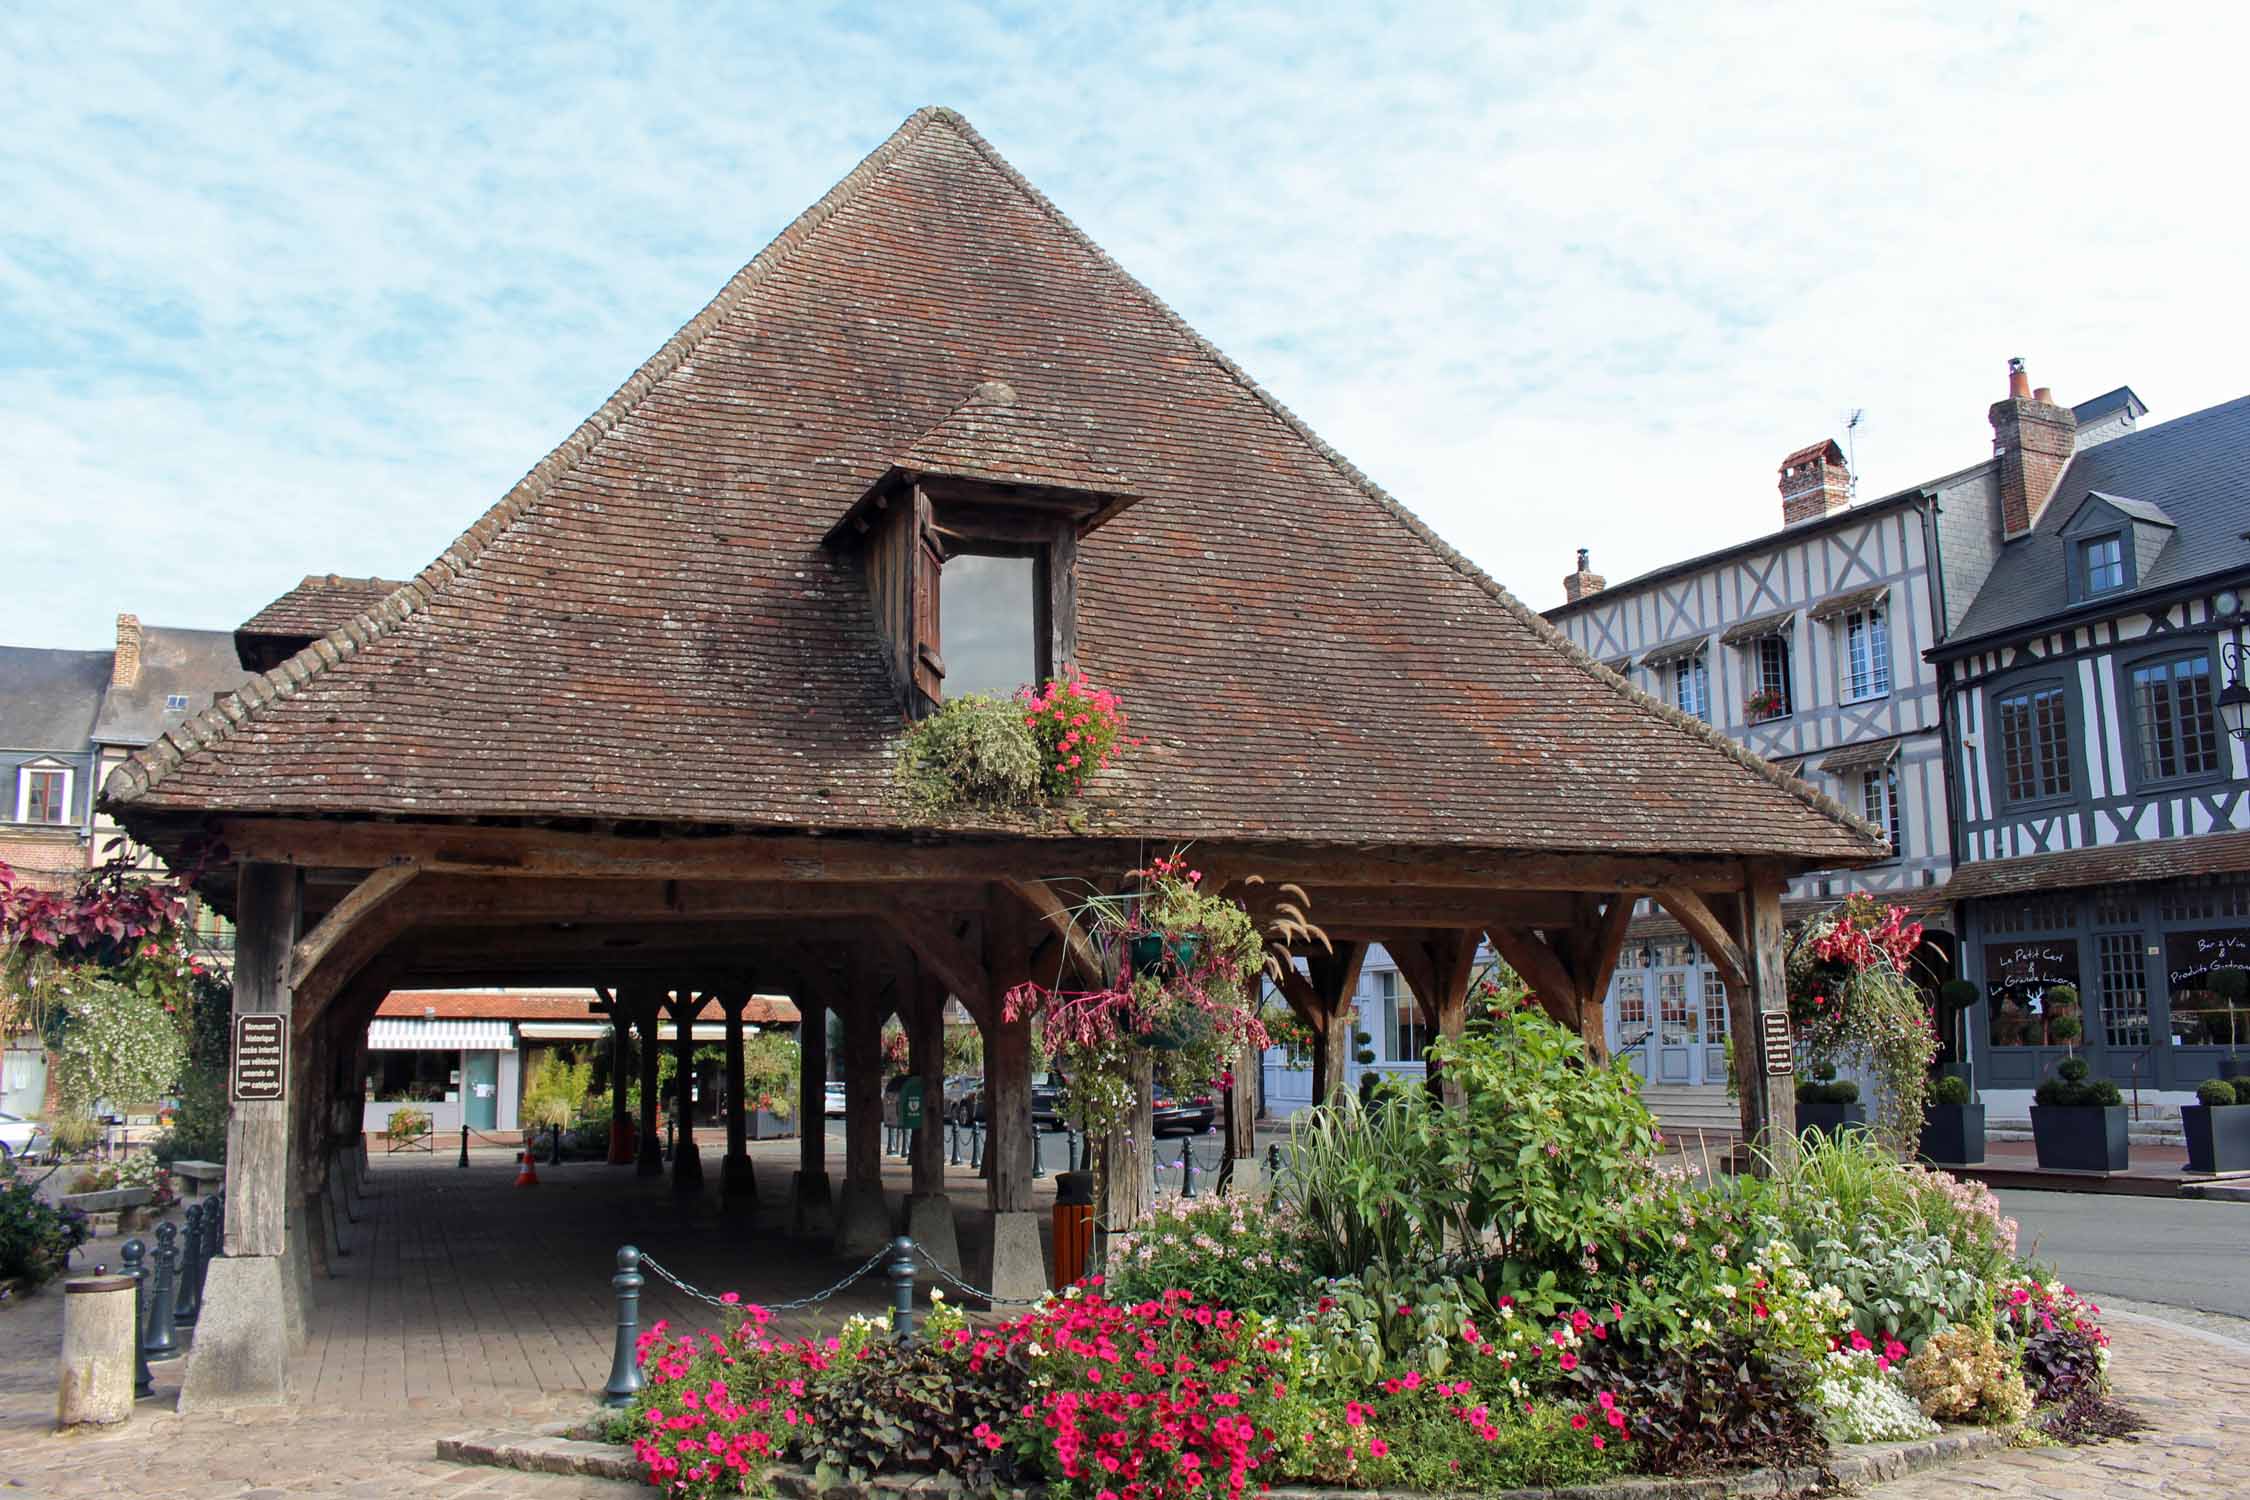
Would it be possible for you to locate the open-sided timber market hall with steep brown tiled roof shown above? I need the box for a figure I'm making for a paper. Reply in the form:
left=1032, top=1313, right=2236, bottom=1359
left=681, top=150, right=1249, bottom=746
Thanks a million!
left=106, top=108, right=1883, bottom=1403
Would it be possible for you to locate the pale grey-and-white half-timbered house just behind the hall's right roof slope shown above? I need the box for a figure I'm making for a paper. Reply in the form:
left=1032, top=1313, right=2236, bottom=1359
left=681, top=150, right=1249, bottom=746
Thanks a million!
left=1548, top=373, right=2142, bottom=1115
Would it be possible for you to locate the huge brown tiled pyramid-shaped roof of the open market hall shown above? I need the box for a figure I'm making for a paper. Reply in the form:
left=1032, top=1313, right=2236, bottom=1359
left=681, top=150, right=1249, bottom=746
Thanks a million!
left=108, top=110, right=1879, bottom=866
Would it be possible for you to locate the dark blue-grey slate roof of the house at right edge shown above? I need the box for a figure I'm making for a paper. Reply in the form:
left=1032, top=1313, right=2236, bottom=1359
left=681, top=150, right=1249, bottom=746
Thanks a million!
left=1931, top=396, right=2250, bottom=657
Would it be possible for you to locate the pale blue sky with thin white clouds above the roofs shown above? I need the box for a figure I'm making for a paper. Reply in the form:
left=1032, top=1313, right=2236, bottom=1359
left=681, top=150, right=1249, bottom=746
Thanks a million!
left=0, top=0, right=2250, bottom=645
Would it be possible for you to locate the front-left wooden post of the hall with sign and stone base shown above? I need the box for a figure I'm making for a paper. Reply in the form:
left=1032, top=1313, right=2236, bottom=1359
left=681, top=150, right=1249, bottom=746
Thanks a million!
left=180, top=861, right=304, bottom=1412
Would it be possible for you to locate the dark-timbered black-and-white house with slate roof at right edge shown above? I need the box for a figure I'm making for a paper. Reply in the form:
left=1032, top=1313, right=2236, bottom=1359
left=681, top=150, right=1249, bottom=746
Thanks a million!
left=1931, top=389, right=2250, bottom=1113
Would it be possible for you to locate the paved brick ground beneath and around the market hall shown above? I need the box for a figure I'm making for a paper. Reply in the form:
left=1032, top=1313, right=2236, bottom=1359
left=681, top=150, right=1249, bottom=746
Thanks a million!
left=0, top=1142, right=2250, bottom=1500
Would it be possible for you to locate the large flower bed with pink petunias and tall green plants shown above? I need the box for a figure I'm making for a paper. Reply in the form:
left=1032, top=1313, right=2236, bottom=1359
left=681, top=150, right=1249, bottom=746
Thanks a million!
left=623, top=1010, right=2106, bottom=1500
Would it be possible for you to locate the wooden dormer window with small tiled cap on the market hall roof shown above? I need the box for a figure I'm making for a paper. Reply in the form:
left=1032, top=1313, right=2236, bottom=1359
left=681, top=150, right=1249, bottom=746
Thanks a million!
left=828, top=382, right=1132, bottom=717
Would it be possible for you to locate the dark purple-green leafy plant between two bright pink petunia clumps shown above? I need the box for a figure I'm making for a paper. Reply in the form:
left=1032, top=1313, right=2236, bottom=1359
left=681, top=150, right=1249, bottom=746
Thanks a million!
left=803, top=1340, right=1031, bottom=1493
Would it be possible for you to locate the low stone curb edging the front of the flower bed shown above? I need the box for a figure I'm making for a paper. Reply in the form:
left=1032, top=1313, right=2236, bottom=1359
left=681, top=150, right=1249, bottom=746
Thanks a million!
left=437, top=1428, right=2016, bottom=1500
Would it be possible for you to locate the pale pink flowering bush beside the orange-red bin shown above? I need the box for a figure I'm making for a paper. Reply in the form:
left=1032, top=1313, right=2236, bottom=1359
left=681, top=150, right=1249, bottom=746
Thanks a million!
left=1103, top=1196, right=1312, bottom=1318
